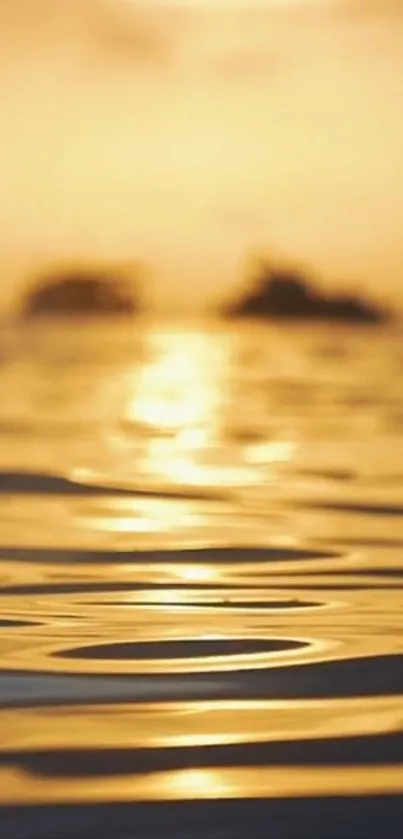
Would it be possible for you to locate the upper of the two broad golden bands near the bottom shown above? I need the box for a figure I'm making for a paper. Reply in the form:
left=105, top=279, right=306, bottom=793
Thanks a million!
left=0, top=697, right=403, bottom=758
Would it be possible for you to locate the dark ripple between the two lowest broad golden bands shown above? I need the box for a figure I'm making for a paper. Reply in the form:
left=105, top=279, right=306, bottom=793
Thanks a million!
left=0, top=732, right=403, bottom=780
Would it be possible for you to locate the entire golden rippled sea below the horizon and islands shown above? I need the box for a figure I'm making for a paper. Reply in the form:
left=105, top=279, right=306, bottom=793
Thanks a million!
left=0, top=323, right=403, bottom=839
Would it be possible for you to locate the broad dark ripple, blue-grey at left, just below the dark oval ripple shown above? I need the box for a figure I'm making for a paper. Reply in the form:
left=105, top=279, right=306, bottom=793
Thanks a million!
left=0, top=648, right=403, bottom=706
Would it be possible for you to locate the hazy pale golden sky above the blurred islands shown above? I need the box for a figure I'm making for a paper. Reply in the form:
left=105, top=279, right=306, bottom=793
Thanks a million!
left=0, top=0, right=403, bottom=306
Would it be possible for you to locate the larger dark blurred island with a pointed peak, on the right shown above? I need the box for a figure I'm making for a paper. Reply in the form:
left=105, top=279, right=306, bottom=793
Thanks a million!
left=221, top=260, right=392, bottom=324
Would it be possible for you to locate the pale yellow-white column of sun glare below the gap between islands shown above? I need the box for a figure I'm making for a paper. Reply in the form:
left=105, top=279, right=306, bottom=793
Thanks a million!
left=124, top=330, right=258, bottom=487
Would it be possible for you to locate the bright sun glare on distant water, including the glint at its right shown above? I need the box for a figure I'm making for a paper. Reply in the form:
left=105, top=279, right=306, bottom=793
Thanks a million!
left=117, top=327, right=296, bottom=491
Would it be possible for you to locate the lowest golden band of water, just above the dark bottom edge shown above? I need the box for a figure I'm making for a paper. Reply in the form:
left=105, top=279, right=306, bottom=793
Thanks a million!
left=0, top=764, right=403, bottom=805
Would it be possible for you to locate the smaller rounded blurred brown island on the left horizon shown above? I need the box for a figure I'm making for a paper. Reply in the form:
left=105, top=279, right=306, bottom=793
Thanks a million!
left=21, top=270, right=141, bottom=319
